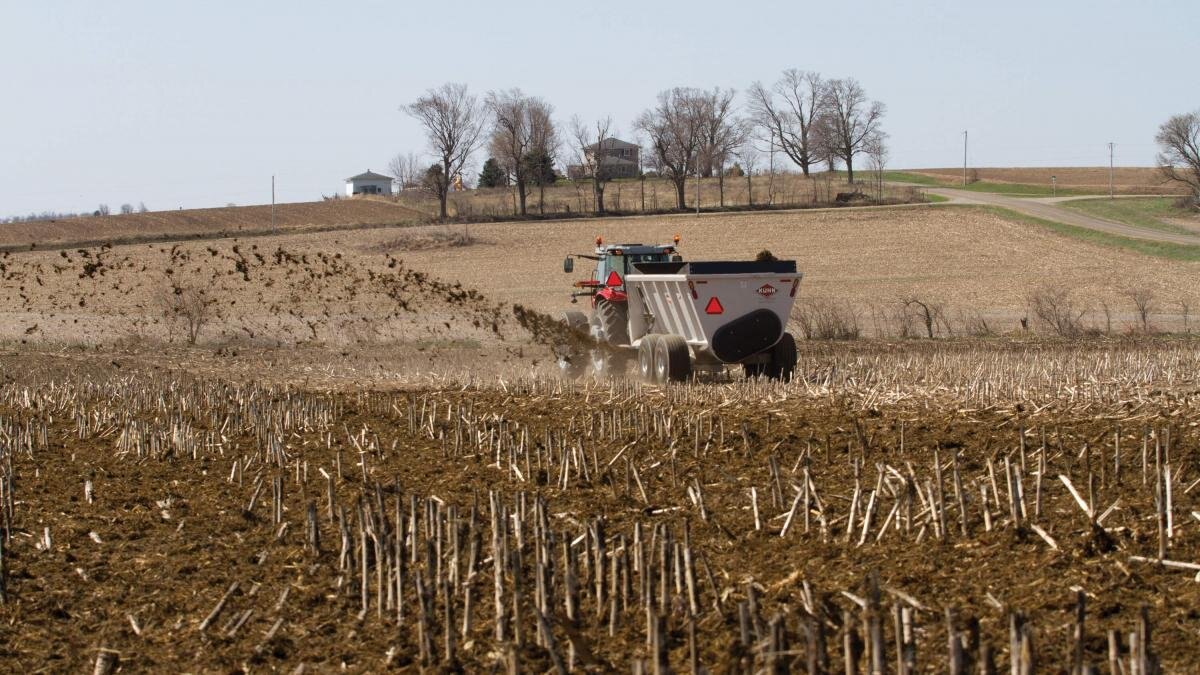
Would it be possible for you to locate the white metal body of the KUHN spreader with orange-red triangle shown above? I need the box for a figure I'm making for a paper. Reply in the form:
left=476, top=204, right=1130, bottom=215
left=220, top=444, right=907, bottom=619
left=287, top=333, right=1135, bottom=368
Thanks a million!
left=625, top=261, right=804, bottom=368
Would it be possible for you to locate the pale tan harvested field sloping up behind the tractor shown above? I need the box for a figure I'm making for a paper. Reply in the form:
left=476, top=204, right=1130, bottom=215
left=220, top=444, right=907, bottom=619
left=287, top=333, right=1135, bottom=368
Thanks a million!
left=0, top=200, right=1200, bottom=348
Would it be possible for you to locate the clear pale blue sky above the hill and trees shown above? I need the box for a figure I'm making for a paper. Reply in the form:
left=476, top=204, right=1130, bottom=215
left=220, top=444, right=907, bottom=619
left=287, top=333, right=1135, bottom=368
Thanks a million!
left=0, top=0, right=1200, bottom=215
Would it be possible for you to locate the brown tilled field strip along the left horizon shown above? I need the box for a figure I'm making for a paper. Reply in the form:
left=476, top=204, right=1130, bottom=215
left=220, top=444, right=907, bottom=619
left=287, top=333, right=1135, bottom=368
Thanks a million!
left=0, top=199, right=425, bottom=247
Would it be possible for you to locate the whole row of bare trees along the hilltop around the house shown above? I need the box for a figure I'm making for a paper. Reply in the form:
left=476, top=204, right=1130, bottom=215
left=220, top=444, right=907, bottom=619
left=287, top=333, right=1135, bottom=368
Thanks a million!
left=389, top=70, right=887, bottom=217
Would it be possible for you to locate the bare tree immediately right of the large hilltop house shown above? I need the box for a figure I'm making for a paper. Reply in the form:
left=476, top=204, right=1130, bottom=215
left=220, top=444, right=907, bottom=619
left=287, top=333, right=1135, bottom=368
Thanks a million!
left=637, top=88, right=707, bottom=210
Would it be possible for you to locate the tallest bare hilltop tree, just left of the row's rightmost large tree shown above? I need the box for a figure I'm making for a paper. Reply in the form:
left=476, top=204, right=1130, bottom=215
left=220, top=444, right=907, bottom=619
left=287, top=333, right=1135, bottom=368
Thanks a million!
left=749, top=68, right=826, bottom=177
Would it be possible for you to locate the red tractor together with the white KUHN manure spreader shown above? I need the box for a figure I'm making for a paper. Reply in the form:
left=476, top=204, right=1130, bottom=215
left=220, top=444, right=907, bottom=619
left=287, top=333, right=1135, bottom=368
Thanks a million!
left=559, top=239, right=803, bottom=383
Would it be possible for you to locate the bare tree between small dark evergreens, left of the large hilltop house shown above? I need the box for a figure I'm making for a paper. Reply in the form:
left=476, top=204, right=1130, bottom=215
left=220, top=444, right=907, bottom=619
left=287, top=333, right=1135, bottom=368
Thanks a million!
left=487, top=89, right=558, bottom=215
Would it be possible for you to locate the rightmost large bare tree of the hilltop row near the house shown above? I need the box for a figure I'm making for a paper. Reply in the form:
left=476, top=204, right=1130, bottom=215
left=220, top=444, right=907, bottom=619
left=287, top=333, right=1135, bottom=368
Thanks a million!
left=815, top=78, right=886, bottom=183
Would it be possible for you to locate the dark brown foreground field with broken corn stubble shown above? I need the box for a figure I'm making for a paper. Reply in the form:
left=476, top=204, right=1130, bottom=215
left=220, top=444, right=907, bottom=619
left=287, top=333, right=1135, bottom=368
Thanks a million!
left=0, top=342, right=1200, bottom=673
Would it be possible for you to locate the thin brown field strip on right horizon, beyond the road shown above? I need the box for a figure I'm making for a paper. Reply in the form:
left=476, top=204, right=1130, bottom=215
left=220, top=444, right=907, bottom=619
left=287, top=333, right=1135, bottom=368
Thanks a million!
left=907, top=167, right=1187, bottom=195
